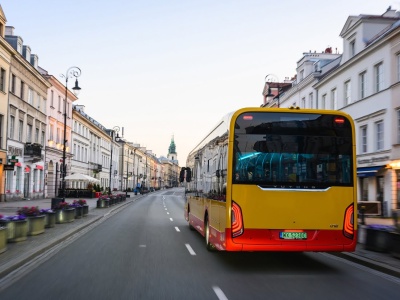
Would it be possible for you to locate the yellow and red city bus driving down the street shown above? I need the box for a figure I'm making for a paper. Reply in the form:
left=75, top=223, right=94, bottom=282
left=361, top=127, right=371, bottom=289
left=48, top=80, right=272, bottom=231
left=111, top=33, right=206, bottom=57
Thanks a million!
left=185, top=107, right=357, bottom=251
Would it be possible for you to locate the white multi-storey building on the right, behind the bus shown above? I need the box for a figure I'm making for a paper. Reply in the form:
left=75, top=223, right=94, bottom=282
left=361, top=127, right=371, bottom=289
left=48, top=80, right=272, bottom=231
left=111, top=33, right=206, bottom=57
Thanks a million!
left=264, top=8, right=400, bottom=216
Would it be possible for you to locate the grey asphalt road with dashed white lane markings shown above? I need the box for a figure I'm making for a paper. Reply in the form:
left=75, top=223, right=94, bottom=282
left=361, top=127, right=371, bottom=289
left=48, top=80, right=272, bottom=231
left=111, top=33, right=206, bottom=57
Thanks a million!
left=0, top=189, right=400, bottom=300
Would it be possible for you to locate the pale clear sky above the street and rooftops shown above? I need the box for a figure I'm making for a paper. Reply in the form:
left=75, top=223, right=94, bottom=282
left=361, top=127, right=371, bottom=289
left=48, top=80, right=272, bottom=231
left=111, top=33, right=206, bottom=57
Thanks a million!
left=0, top=0, right=400, bottom=166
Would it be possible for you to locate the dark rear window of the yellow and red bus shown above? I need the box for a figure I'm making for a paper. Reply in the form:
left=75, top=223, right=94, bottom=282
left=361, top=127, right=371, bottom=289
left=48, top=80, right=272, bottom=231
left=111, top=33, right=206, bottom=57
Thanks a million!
left=233, top=112, right=353, bottom=188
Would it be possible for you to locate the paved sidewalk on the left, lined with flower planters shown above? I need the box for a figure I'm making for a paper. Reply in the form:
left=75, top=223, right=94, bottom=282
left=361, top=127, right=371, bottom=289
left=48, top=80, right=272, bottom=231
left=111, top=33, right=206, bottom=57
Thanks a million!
left=0, top=193, right=141, bottom=280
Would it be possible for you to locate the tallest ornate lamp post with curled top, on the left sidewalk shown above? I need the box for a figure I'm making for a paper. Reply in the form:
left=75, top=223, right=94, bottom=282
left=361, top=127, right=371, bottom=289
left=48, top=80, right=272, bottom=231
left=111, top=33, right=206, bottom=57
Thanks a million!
left=61, top=67, right=81, bottom=202
